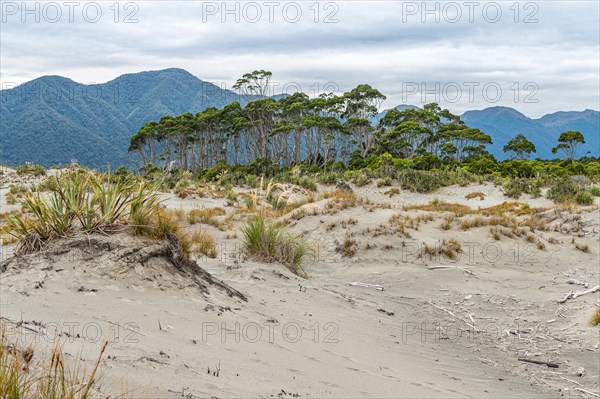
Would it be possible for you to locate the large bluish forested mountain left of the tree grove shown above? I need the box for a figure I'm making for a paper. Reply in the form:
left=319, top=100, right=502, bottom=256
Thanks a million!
left=0, top=69, right=244, bottom=167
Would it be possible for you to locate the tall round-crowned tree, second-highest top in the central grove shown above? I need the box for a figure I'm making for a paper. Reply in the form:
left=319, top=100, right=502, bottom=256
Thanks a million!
left=342, top=84, right=386, bottom=159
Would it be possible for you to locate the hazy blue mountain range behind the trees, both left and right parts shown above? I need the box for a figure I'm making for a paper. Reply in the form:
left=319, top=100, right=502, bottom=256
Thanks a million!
left=0, top=69, right=600, bottom=168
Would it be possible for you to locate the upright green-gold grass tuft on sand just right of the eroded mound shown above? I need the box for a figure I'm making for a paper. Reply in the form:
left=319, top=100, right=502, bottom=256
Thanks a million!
left=242, top=216, right=310, bottom=277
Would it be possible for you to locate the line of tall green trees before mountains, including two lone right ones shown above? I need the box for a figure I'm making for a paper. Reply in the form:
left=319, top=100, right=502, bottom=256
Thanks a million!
left=129, top=70, right=584, bottom=172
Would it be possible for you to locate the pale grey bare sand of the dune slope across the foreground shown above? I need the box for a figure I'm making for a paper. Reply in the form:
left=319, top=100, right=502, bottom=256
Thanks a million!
left=0, top=180, right=600, bottom=398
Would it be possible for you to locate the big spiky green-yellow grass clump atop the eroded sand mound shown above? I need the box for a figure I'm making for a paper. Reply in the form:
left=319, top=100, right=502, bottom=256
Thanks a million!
left=7, top=171, right=159, bottom=254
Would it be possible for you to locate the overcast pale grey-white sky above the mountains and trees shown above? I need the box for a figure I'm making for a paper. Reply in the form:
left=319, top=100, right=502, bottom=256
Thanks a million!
left=0, top=0, right=600, bottom=117
